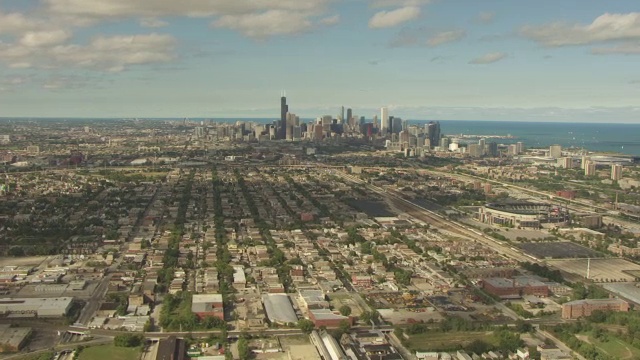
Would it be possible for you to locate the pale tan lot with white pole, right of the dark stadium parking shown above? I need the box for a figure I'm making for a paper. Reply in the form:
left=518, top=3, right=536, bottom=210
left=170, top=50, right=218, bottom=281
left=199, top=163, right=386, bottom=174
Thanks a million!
left=547, top=259, right=640, bottom=282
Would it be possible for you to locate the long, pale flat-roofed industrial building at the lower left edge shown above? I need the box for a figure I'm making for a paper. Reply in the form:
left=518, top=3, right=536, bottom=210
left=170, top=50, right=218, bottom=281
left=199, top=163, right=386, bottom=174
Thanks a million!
left=0, top=297, right=73, bottom=317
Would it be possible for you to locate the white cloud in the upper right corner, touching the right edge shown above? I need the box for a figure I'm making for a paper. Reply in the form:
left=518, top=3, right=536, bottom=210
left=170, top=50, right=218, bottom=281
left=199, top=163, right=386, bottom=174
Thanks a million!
left=520, top=12, right=640, bottom=47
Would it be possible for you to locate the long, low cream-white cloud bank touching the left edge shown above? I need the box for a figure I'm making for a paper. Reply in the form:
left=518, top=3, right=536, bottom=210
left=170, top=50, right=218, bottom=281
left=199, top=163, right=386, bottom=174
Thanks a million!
left=0, top=34, right=175, bottom=72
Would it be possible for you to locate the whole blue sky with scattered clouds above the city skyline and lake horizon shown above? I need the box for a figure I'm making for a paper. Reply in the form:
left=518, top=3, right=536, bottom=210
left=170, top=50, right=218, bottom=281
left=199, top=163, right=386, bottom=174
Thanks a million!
left=0, top=0, right=640, bottom=123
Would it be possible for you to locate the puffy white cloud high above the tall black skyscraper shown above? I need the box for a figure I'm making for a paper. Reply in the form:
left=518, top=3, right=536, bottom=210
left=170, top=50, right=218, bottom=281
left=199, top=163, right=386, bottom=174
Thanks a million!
left=213, top=10, right=311, bottom=39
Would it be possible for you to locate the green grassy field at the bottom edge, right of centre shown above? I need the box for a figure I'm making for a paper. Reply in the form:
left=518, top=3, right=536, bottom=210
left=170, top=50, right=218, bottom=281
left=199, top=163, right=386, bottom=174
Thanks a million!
left=405, top=331, right=496, bottom=351
